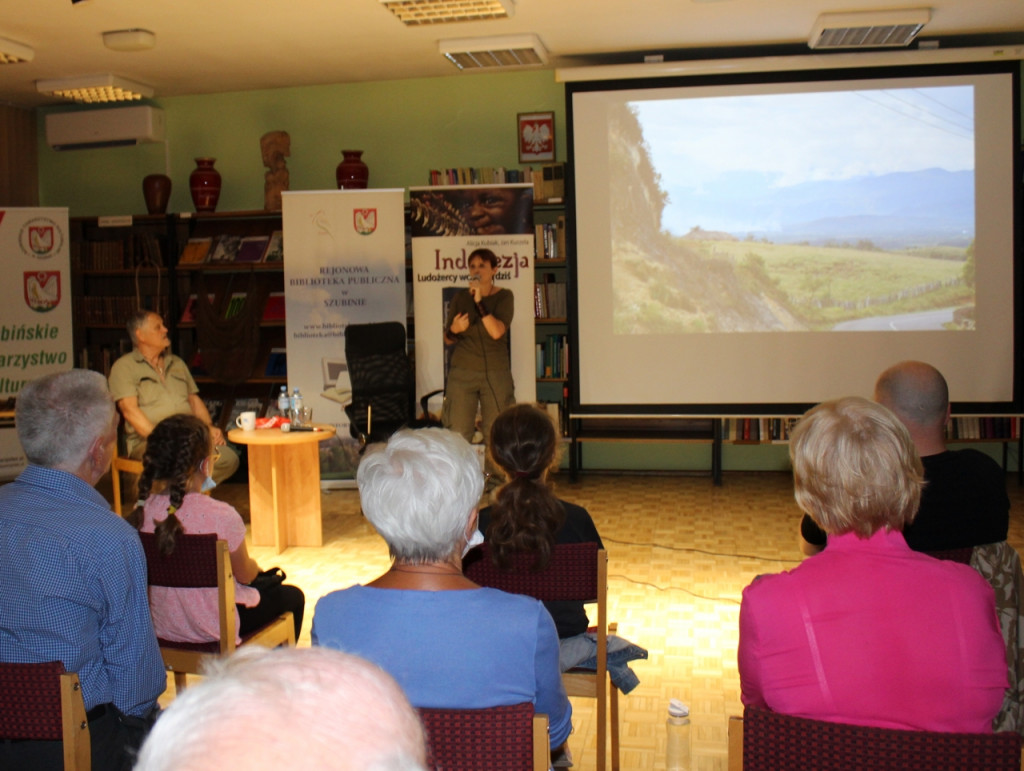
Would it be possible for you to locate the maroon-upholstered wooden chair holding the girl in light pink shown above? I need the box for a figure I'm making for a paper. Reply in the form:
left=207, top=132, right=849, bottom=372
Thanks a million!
left=139, top=532, right=295, bottom=690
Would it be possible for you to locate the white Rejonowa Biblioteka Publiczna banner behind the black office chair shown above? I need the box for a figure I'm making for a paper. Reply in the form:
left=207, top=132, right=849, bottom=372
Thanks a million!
left=282, top=189, right=407, bottom=487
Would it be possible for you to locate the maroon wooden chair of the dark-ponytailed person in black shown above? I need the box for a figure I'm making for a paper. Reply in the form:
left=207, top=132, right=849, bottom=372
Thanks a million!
left=463, top=543, right=618, bottom=771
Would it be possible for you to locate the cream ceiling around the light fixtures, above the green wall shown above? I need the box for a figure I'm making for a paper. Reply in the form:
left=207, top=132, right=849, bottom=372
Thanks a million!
left=0, top=0, right=1024, bottom=106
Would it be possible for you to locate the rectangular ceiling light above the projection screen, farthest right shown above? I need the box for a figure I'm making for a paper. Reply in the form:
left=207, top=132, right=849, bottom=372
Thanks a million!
left=807, top=8, right=932, bottom=48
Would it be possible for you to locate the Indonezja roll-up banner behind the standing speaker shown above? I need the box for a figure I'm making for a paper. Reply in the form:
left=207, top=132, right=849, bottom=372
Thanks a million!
left=410, top=184, right=537, bottom=427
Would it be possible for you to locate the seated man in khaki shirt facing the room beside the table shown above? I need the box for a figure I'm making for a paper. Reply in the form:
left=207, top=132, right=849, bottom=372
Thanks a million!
left=111, top=310, right=239, bottom=482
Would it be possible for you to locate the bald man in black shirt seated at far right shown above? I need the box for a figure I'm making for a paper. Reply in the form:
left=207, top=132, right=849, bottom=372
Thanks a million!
left=800, top=361, right=1010, bottom=555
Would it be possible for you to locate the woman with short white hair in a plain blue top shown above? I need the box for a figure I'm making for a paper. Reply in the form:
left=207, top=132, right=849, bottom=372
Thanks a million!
left=312, top=428, right=572, bottom=748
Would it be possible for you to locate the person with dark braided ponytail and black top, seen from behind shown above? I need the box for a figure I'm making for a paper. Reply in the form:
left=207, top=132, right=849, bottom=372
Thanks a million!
left=479, top=404, right=647, bottom=693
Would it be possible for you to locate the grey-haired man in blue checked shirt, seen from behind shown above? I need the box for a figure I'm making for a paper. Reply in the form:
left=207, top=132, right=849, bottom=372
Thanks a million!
left=0, top=370, right=167, bottom=769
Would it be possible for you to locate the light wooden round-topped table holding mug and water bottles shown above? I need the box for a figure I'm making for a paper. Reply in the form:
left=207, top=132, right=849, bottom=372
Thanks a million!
left=227, top=424, right=334, bottom=554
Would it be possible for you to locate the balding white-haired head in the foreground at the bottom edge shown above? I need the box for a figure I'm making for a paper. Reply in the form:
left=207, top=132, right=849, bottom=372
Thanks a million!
left=135, top=645, right=425, bottom=771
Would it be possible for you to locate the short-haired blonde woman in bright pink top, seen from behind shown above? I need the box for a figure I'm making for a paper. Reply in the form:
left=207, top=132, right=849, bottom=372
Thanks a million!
left=739, top=397, right=1007, bottom=733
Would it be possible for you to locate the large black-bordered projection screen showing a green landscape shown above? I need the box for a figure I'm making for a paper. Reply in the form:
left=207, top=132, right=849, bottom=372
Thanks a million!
left=566, top=61, right=1021, bottom=415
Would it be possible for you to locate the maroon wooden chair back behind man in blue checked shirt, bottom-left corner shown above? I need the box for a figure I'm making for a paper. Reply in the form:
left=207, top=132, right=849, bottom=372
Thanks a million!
left=0, top=661, right=92, bottom=771
